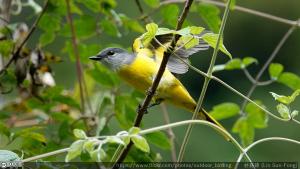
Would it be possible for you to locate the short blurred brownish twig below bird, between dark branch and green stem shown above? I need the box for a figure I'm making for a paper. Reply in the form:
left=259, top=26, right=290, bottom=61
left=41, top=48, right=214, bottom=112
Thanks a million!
left=160, top=103, right=177, bottom=162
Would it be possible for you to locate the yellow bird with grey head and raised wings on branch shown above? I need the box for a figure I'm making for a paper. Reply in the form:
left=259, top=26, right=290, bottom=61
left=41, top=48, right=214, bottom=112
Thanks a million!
left=90, top=34, right=223, bottom=128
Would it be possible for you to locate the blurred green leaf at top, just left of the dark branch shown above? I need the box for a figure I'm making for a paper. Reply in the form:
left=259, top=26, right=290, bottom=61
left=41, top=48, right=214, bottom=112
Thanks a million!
left=160, top=4, right=179, bottom=26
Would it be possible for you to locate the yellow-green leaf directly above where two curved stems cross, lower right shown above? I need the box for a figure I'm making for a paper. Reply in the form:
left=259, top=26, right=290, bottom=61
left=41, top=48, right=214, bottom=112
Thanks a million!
left=232, top=117, right=255, bottom=147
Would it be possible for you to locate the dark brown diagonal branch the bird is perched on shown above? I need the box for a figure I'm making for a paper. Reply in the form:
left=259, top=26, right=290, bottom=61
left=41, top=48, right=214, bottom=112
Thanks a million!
left=113, top=0, right=193, bottom=168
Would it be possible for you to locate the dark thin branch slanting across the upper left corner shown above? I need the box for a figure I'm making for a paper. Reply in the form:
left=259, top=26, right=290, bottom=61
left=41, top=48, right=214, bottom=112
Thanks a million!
left=0, top=0, right=49, bottom=75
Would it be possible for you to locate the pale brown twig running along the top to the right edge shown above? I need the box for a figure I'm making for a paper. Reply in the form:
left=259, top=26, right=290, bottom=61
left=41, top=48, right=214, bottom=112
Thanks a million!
left=160, top=0, right=300, bottom=27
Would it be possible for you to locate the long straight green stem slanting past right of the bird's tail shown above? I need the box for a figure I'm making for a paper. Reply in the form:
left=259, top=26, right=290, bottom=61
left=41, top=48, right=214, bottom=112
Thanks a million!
left=177, top=0, right=231, bottom=162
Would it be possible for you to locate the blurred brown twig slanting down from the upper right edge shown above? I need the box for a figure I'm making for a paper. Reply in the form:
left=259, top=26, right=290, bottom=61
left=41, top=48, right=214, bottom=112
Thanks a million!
left=240, top=25, right=296, bottom=114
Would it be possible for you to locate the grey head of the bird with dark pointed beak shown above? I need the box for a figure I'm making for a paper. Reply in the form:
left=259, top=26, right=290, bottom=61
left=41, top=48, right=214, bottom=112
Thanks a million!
left=89, top=48, right=135, bottom=70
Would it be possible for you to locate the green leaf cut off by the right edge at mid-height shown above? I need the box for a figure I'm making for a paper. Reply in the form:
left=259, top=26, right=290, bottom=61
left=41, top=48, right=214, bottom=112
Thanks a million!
left=277, top=72, right=300, bottom=90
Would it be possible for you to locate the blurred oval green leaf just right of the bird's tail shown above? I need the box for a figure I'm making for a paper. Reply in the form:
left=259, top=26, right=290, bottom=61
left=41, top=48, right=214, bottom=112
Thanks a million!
left=209, top=102, right=240, bottom=120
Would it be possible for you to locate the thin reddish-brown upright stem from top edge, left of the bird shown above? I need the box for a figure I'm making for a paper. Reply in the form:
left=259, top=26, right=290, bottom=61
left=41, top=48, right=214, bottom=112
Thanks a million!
left=66, top=0, right=85, bottom=114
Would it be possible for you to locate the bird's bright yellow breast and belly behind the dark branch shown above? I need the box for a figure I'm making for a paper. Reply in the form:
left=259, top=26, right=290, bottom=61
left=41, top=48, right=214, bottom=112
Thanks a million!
left=117, top=51, right=195, bottom=111
